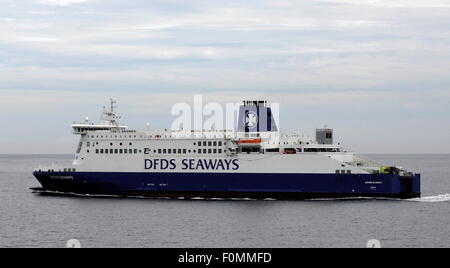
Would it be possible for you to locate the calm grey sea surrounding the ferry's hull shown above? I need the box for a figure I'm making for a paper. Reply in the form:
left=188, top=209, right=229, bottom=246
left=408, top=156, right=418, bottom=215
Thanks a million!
left=0, top=155, right=450, bottom=247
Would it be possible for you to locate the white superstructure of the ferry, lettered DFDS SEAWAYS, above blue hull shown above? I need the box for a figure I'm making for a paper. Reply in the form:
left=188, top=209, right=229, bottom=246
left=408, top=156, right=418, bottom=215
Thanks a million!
left=61, top=101, right=380, bottom=174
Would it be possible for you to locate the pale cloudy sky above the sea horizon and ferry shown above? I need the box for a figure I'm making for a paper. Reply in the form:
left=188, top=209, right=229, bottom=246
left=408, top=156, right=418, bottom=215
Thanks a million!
left=0, top=0, right=450, bottom=154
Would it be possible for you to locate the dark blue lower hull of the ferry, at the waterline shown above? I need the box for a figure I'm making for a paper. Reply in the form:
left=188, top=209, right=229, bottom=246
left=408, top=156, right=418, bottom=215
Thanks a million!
left=33, top=171, right=420, bottom=200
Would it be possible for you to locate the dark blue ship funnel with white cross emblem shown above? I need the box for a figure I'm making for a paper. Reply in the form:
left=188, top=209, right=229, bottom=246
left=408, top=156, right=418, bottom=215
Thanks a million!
left=238, top=101, right=278, bottom=132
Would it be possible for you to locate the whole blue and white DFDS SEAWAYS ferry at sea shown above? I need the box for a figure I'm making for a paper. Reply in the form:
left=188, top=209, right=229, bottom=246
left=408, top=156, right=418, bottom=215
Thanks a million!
left=33, top=100, right=421, bottom=200
